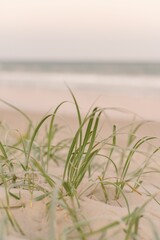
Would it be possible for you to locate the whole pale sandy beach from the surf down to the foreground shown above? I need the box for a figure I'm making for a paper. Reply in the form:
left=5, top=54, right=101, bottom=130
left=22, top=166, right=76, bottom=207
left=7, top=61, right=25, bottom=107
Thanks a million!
left=0, top=87, right=160, bottom=240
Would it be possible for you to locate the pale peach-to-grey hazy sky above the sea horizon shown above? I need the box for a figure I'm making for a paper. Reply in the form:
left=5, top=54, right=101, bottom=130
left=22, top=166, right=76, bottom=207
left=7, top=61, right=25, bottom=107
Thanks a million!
left=0, top=0, right=160, bottom=61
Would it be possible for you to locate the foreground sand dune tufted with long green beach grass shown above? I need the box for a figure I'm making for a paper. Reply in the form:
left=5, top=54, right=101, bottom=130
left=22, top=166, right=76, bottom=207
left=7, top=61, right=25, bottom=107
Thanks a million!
left=0, top=94, right=160, bottom=240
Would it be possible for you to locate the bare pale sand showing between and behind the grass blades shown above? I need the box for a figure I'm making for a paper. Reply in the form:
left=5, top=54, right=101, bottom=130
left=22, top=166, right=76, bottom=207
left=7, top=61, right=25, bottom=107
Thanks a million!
left=0, top=85, right=160, bottom=240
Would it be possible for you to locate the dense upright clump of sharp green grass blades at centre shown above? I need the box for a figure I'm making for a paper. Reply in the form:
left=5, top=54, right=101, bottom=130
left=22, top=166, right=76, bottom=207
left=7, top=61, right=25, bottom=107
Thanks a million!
left=63, top=108, right=102, bottom=196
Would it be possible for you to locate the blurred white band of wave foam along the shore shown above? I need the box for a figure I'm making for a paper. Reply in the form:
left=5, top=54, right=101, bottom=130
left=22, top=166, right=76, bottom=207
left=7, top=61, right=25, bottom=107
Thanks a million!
left=0, top=71, right=160, bottom=94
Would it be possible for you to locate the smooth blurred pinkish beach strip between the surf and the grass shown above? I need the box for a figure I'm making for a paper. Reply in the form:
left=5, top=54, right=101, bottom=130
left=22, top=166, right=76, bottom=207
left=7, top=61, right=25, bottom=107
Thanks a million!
left=0, top=85, right=160, bottom=121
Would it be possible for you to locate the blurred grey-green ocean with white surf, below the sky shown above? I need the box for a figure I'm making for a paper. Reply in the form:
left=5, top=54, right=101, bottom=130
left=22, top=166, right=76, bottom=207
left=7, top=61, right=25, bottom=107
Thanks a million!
left=0, top=62, right=160, bottom=95
